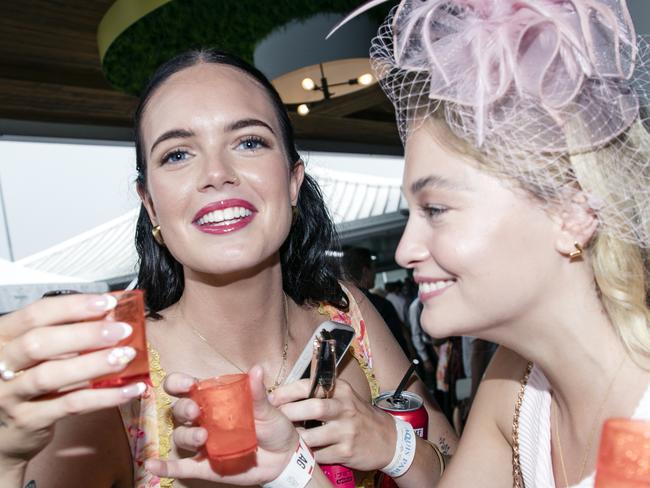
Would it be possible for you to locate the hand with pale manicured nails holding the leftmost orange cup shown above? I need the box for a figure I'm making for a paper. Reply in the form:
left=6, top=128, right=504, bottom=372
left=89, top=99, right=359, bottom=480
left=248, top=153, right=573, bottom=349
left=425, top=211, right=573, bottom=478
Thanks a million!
left=0, top=294, right=145, bottom=471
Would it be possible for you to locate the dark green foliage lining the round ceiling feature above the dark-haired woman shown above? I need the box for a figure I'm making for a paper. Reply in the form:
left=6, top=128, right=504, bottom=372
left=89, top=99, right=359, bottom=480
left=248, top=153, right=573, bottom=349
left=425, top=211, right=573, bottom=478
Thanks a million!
left=102, top=0, right=390, bottom=95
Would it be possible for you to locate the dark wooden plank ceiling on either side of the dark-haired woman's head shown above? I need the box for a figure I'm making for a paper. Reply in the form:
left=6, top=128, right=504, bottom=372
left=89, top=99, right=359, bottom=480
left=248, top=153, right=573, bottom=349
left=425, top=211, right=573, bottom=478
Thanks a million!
left=0, top=0, right=400, bottom=150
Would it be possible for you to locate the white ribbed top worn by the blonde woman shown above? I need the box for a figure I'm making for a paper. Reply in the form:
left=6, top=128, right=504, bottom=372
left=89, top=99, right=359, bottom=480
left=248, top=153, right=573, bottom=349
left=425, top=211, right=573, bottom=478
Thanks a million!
left=519, top=366, right=650, bottom=488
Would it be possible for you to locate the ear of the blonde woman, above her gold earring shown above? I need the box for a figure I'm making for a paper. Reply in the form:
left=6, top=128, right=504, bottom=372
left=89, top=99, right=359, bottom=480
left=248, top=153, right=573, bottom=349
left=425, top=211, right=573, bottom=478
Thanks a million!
left=556, top=191, right=598, bottom=255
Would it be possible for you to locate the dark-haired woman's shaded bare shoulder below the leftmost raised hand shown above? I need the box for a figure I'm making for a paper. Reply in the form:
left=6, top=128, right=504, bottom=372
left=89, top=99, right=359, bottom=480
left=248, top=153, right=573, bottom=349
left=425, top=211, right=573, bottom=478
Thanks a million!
left=25, top=408, right=133, bottom=488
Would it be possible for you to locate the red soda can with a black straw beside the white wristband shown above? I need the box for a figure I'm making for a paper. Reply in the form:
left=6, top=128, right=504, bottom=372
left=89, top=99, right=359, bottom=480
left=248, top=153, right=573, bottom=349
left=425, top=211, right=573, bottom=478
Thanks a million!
left=375, top=391, right=429, bottom=488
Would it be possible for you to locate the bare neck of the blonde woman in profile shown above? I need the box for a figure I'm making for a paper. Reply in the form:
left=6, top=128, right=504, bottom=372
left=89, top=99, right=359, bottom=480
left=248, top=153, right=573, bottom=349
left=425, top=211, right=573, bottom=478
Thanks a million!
left=478, top=263, right=631, bottom=424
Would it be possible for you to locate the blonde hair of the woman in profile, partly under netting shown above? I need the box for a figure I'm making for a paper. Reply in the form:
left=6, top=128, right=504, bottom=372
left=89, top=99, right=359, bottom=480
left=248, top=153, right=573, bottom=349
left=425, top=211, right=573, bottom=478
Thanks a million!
left=422, top=107, right=650, bottom=368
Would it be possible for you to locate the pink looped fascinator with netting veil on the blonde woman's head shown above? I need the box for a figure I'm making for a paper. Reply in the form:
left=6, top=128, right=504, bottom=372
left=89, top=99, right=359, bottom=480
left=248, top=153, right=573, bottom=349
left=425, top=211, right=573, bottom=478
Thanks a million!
left=330, top=0, right=650, bottom=247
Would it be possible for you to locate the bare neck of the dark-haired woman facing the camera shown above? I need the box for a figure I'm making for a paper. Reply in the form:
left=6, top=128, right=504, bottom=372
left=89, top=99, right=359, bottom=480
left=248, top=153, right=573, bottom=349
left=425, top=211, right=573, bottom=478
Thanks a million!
left=171, top=255, right=286, bottom=369
